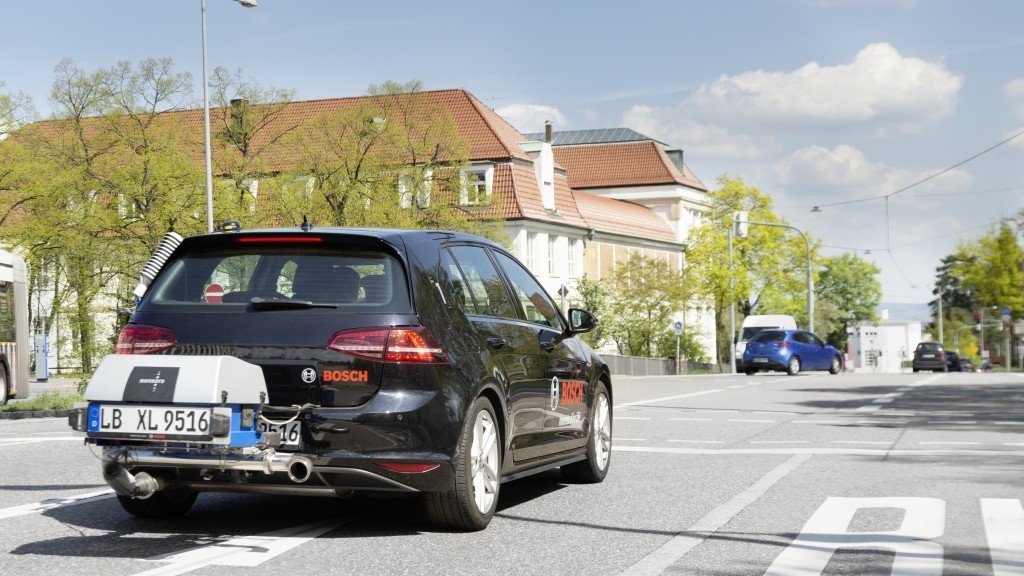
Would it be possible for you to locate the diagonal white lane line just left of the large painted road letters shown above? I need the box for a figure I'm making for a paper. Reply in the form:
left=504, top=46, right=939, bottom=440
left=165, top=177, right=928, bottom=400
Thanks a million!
left=625, top=455, right=810, bottom=576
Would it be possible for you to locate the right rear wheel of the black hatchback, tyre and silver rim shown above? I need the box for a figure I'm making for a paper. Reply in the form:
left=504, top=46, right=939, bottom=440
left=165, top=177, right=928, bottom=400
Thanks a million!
left=424, top=398, right=502, bottom=532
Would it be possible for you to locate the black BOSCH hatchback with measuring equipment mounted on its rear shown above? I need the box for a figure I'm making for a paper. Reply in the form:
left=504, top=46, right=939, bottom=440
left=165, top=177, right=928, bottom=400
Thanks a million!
left=70, top=227, right=612, bottom=530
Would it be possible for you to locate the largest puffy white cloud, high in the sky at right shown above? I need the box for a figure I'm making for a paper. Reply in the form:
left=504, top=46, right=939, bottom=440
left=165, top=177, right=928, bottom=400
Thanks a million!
left=623, top=43, right=964, bottom=158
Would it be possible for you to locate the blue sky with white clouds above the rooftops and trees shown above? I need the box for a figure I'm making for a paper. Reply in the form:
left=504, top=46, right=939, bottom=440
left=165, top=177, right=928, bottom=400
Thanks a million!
left=0, top=0, right=1024, bottom=311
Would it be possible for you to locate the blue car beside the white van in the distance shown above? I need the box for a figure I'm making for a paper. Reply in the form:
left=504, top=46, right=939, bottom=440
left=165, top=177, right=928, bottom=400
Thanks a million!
left=743, top=330, right=843, bottom=376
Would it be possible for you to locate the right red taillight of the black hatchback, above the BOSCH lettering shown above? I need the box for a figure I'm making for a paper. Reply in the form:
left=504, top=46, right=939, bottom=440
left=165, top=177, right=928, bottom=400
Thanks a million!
left=327, top=326, right=447, bottom=364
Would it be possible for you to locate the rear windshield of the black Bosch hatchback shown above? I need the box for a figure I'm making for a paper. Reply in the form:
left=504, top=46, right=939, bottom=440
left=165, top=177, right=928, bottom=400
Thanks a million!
left=140, top=245, right=412, bottom=314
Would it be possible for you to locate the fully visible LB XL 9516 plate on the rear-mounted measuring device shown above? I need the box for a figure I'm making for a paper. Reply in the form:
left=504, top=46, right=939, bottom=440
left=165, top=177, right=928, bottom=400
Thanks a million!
left=87, top=404, right=212, bottom=440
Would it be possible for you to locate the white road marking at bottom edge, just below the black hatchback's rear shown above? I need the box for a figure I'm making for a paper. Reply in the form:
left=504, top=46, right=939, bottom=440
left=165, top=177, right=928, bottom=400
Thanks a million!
left=136, top=517, right=354, bottom=576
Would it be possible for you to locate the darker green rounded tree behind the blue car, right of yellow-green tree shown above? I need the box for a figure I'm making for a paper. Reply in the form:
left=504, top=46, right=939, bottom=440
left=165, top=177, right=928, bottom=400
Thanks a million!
left=815, top=254, right=882, bottom=349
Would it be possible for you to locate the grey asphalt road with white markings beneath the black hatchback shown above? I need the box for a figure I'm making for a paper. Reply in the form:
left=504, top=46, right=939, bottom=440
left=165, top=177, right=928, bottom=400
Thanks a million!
left=0, top=366, right=1024, bottom=576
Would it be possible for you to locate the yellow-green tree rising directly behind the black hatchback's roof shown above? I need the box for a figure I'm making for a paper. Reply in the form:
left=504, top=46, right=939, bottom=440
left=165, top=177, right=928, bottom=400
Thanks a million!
left=282, top=81, right=505, bottom=241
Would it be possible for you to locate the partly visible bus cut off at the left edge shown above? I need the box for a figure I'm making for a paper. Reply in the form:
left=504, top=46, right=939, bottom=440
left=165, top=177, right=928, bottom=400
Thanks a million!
left=0, top=250, right=29, bottom=406
